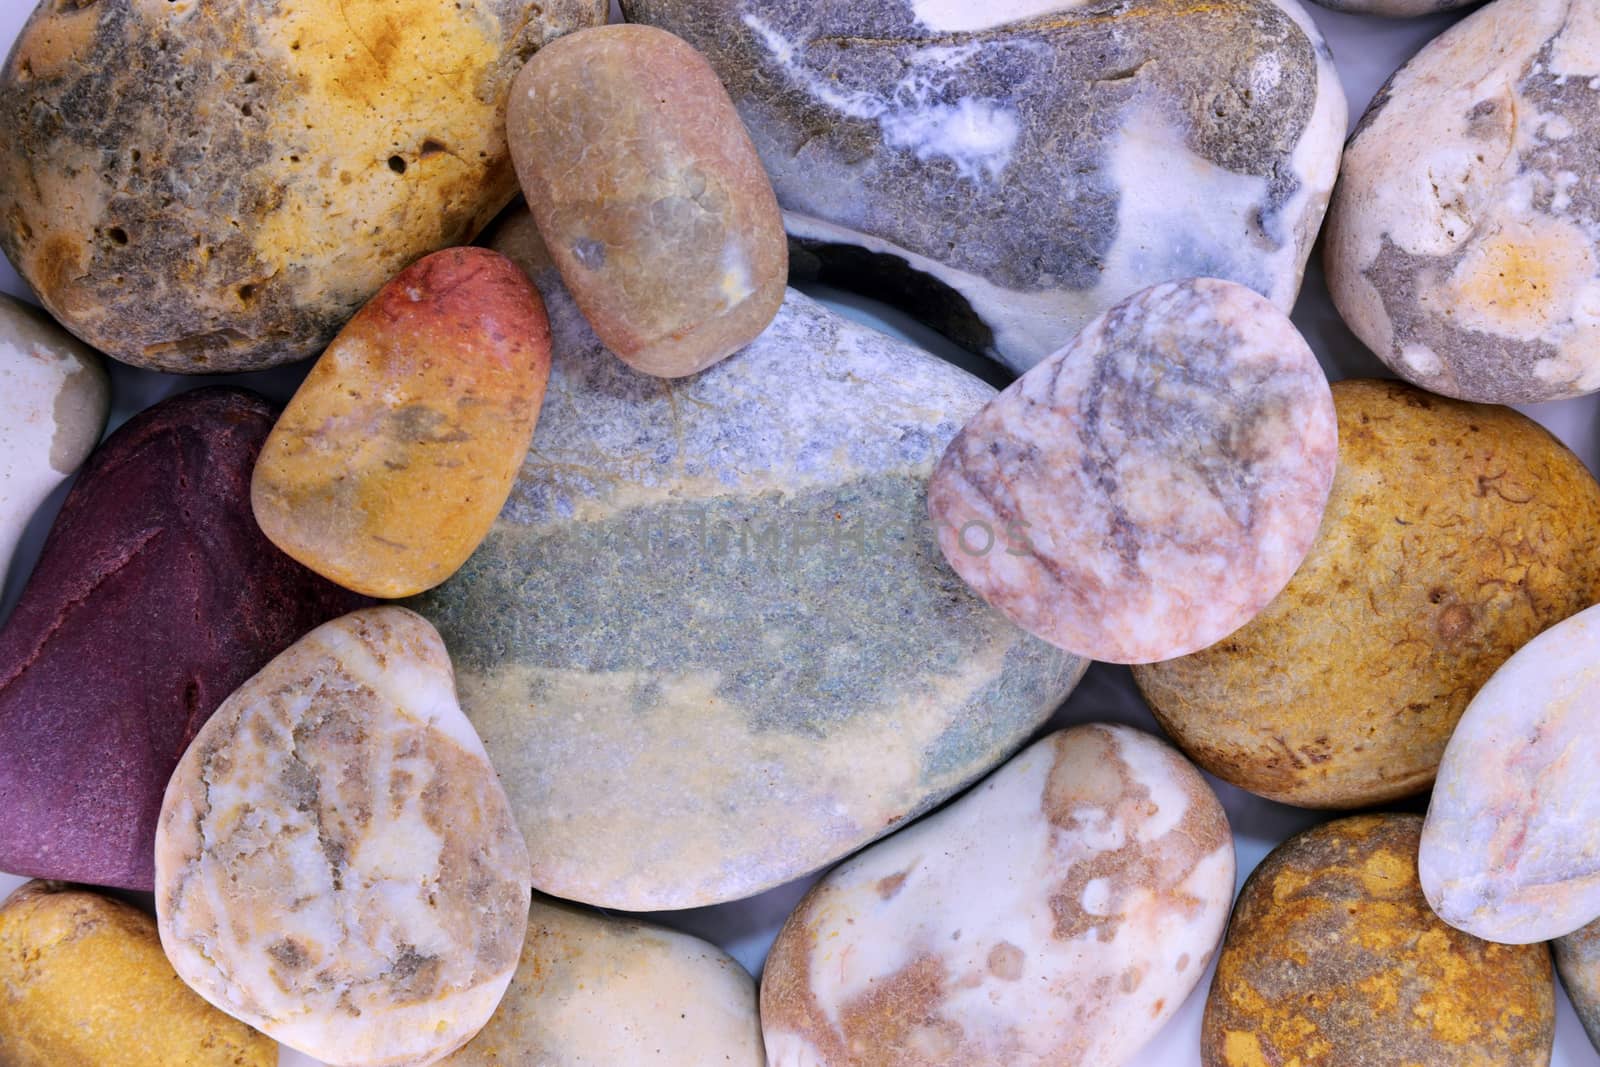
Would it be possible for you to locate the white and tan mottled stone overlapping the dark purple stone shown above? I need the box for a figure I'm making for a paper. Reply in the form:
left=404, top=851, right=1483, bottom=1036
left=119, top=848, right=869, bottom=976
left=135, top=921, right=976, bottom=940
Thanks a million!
left=155, top=606, right=530, bottom=1067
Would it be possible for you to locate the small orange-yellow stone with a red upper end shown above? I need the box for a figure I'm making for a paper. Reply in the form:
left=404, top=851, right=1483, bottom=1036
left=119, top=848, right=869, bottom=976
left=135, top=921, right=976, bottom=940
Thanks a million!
left=251, top=248, right=550, bottom=598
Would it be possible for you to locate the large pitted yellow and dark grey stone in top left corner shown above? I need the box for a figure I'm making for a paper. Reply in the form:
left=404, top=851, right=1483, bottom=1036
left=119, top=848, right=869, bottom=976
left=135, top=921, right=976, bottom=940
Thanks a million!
left=0, top=0, right=606, bottom=373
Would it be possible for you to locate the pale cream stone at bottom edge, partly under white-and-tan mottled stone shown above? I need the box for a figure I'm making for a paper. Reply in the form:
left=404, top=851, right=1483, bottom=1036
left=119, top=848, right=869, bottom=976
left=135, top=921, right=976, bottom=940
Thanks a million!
left=442, top=899, right=766, bottom=1067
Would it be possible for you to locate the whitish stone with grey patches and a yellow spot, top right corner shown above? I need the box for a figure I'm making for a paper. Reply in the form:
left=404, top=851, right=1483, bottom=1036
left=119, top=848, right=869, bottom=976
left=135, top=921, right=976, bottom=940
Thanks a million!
left=1326, top=0, right=1600, bottom=403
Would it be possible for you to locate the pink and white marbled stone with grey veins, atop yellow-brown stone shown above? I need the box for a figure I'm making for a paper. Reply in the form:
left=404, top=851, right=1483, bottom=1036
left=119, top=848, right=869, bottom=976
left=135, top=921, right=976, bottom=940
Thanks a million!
left=928, top=278, right=1338, bottom=662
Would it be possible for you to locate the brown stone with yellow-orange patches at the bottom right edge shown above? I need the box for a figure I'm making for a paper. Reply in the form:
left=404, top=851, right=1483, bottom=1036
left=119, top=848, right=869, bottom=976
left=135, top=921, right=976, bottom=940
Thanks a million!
left=1200, top=814, right=1555, bottom=1067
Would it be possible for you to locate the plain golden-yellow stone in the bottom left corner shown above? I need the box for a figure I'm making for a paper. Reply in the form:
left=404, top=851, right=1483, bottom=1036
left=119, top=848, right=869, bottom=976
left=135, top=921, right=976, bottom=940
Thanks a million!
left=0, top=881, right=278, bottom=1067
